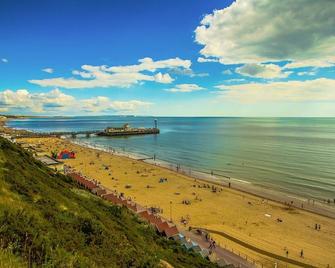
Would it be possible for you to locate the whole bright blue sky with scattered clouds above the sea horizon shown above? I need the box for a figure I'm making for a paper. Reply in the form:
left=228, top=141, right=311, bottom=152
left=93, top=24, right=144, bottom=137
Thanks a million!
left=0, top=0, right=335, bottom=117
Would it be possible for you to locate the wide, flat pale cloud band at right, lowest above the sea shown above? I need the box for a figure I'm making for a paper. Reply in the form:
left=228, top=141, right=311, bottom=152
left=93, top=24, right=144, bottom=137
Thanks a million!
left=217, top=78, right=335, bottom=103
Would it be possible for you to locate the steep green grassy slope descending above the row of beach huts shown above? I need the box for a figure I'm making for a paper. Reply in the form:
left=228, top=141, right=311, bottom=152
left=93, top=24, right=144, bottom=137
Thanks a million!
left=0, top=138, right=217, bottom=267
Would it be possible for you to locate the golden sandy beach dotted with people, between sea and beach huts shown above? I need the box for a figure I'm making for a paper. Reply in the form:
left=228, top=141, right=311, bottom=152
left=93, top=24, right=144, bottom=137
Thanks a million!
left=22, top=138, right=335, bottom=267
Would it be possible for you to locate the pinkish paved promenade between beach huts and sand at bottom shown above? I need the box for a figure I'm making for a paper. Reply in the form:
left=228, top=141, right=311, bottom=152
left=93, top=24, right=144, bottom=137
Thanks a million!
left=182, top=228, right=255, bottom=268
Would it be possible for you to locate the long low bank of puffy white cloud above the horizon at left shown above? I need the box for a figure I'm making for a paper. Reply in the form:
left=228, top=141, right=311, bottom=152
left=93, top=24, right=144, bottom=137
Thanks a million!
left=0, top=89, right=151, bottom=114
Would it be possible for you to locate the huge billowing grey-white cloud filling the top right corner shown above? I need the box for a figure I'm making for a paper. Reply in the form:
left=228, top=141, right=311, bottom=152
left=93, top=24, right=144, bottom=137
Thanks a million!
left=195, top=0, right=335, bottom=68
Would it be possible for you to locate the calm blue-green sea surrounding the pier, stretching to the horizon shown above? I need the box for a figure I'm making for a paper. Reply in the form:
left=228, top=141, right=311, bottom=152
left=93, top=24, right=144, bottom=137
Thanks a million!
left=8, top=116, right=335, bottom=199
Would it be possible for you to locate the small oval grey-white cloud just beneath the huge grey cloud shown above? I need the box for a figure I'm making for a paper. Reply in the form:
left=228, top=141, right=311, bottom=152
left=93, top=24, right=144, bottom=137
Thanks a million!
left=235, top=63, right=292, bottom=79
